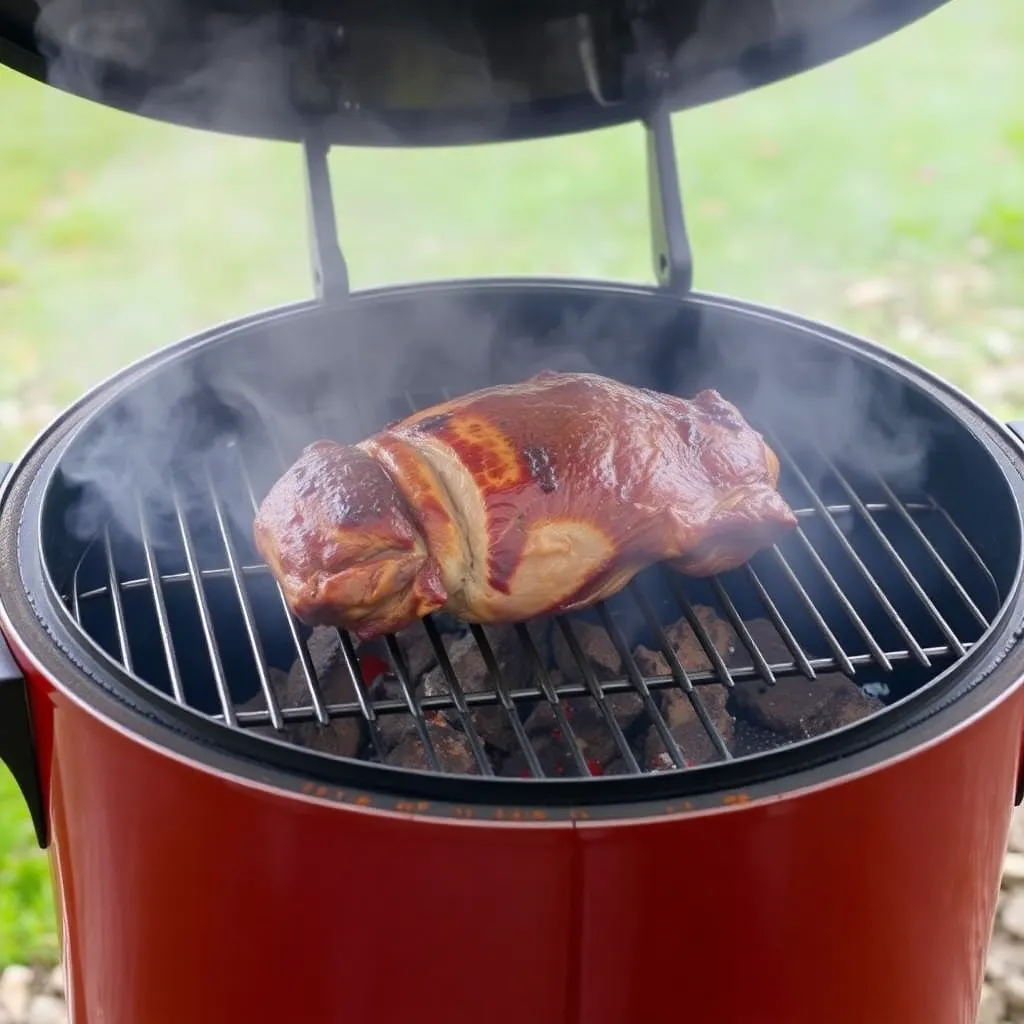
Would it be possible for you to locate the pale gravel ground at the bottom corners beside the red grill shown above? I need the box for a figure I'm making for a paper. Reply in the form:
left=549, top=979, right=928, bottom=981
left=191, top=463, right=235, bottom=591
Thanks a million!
left=0, top=809, right=1024, bottom=1024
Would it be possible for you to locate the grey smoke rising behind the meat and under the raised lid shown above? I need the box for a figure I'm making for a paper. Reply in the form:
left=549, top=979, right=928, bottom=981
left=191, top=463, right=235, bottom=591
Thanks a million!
left=29, top=0, right=931, bottom=561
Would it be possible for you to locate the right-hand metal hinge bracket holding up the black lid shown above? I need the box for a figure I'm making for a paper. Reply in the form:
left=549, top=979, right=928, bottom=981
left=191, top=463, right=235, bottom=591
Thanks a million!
left=644, top=106, right=693, bottom=295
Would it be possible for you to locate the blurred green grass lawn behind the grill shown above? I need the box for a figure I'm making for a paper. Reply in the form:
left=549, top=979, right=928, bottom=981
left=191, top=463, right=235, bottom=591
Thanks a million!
left=0, top=0, right=1024, bottom=964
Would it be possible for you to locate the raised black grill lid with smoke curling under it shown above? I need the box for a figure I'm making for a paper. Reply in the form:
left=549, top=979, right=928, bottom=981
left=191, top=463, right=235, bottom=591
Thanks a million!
left=6, top=0, right=945, bottom=145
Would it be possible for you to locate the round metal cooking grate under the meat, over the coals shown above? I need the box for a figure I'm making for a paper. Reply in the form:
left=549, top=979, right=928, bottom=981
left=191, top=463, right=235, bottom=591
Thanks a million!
left=66, top=387, right=999, bottom=778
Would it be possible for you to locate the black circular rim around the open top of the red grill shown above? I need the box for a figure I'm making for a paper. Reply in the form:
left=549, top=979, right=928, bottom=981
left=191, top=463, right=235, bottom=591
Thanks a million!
left=0, top=279, right=1024, bottom=821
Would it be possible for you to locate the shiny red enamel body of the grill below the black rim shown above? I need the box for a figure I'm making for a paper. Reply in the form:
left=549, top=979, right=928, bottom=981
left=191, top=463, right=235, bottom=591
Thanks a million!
left=8, top=622, right=1024, bottom=1024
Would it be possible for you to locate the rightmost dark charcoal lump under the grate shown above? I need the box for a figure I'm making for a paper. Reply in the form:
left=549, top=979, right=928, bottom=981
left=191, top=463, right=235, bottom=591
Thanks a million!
left=732, top=672, right=885, bottom=739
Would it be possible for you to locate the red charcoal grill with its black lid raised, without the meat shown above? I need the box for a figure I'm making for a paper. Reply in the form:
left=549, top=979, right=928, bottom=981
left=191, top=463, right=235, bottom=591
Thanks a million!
left=0, top=0, right=1024, bottom=1024
